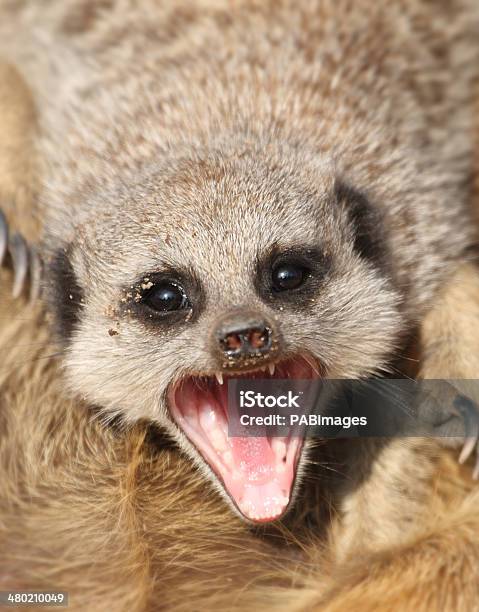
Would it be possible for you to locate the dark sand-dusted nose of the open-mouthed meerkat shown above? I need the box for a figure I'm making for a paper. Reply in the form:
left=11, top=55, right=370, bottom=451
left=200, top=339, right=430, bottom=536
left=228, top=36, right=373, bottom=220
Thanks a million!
left=215, top=312, right=274, bottom=361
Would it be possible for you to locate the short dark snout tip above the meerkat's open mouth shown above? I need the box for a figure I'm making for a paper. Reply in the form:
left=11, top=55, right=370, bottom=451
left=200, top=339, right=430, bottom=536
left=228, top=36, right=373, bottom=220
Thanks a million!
left=213, top=309, right=279, bottom=368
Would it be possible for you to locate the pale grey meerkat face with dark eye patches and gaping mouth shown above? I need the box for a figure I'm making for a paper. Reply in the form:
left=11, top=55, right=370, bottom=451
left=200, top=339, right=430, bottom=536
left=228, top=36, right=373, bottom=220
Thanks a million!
left=46, top=148, right=401, bottom=521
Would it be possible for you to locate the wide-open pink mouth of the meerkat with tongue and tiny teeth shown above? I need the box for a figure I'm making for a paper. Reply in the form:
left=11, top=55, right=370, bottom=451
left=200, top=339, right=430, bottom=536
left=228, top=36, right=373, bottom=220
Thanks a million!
left=169, top=355, right=320, bottom=522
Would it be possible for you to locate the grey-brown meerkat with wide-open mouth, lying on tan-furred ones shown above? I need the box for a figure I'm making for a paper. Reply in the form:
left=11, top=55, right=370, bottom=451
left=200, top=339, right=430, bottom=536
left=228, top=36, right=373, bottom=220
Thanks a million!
left=0, top=0, right=479, bottom=522
